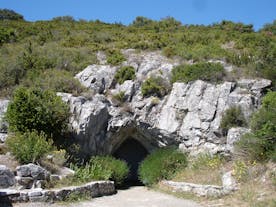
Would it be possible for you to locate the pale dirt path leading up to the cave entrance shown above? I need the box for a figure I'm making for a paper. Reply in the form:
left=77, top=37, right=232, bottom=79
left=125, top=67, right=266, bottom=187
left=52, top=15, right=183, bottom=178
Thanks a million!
left=13, top=187, right=201, bottom=207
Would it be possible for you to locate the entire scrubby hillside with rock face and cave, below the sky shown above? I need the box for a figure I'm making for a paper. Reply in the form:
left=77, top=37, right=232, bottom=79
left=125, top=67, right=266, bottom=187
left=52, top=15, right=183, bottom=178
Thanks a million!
left=0, top=9, right=276, bottom=207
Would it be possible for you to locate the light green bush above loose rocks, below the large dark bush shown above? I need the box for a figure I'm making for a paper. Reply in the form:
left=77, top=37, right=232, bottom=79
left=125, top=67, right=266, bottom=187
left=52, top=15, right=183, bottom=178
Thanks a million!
left=6, top=131, right=53, bottom=164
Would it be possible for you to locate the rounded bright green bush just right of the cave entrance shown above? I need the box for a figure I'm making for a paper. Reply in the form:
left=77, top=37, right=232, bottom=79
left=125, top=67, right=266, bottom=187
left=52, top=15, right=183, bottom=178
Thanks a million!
left=138, top=147, right=187, bottom=185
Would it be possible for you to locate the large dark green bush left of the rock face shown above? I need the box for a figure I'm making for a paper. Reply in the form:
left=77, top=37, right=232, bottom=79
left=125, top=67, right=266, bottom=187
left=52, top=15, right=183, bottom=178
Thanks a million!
left=6, top=87, right=70, bottom=141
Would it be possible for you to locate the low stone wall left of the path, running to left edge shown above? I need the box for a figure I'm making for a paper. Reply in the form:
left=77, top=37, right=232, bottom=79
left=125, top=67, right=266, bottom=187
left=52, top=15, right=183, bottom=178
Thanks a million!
left=0, top=181, right=116, bottom=203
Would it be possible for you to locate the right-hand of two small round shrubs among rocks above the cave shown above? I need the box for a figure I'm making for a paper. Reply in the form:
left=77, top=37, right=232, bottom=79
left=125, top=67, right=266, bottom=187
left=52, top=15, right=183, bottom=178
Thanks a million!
left=141, top=76, right=169, bottom=97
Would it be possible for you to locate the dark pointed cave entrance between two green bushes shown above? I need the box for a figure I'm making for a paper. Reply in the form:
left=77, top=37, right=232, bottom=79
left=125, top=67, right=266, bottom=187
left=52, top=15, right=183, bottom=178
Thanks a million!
left=113, top=138, right=148, bottom=185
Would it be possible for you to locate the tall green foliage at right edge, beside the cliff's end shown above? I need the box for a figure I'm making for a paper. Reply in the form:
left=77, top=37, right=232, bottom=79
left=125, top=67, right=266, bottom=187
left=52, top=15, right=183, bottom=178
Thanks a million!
left=236, top=91, right=276, bottom=162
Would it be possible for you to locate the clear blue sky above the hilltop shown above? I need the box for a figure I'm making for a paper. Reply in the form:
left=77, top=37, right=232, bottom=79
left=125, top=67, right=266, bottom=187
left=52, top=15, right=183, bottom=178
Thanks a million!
left=0, top=0, right=276, bottom=29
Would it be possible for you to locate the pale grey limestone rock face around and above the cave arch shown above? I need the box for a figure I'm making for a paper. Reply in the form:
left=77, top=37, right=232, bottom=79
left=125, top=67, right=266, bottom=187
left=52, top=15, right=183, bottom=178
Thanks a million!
left=56, top=50, right=271, bottom=155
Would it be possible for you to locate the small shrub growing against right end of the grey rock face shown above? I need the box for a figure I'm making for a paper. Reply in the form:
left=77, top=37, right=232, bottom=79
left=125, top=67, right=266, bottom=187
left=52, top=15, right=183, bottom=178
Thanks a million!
left=220, top=106, right=247, bottom=135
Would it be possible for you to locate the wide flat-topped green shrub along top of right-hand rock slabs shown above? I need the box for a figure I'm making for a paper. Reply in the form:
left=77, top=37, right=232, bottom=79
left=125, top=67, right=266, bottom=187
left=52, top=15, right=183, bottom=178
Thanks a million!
left=171, top=62, right=224, bottom=83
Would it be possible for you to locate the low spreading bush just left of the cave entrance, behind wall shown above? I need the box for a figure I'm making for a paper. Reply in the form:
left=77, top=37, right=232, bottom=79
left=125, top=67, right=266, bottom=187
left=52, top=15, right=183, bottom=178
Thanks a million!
left=74, top=156, right=129, bottom=186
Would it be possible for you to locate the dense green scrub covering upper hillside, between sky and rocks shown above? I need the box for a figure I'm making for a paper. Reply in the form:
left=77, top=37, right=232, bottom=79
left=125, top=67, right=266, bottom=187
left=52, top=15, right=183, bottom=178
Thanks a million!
left=0, top=10, right=276, bottom=96
